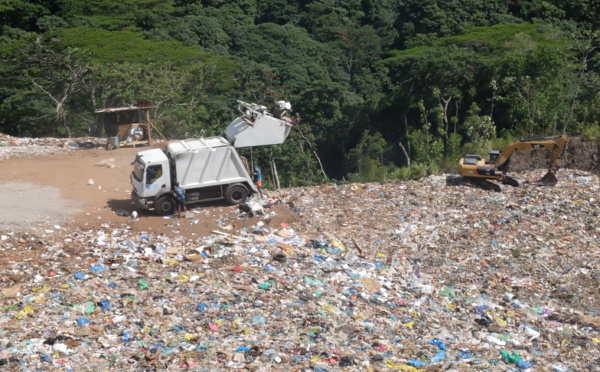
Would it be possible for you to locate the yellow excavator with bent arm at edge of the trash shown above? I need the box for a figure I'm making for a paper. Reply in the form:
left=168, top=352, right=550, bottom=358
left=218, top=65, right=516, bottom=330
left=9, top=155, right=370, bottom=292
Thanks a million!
left=458, top=135, right=567, bottom=192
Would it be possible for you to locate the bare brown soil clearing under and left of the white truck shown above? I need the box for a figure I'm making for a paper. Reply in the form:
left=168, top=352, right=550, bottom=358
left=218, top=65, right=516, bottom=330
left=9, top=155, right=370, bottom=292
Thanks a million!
left=0, top=145, right=299, bottom=238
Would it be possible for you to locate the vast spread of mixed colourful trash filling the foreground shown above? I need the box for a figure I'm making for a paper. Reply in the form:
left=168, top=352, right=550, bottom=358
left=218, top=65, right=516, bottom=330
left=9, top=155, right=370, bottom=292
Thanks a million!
left=0, top=140, right=600, bottom=372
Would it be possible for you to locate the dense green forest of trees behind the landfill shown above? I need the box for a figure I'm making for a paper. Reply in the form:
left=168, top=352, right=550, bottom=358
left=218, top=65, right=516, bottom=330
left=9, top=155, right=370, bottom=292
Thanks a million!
left=0, top=0, right=600, bottom=188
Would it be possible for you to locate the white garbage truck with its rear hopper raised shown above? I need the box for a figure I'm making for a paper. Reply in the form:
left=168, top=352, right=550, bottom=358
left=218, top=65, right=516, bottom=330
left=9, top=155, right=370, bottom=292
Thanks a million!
left=130, top=101, right=293, bottom=215
